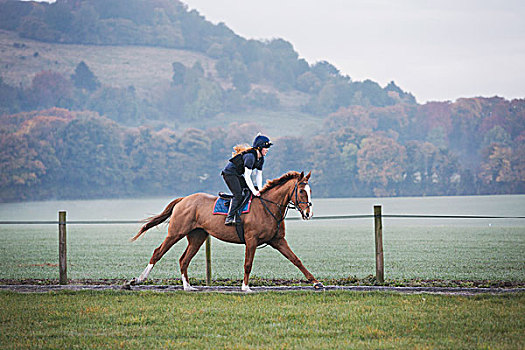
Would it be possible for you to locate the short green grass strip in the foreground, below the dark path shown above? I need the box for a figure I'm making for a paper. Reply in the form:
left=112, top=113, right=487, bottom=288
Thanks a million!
left=0, top=291, right=525, bottom=349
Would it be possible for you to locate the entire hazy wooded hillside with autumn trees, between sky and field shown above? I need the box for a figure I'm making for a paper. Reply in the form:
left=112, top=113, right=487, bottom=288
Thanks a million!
left=0, top=0, right=525, bottom=201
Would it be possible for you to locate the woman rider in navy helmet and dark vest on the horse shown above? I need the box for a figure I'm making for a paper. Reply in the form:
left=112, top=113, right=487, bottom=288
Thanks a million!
left=221, top=133, right=272, bottom=225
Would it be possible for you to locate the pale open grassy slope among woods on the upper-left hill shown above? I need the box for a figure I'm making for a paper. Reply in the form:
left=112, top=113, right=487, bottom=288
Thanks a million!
left=0, top=30, right=213, bottom=103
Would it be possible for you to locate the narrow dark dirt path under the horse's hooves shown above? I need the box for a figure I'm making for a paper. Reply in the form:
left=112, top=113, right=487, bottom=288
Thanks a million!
left=0, top=284, right=525, bottom=295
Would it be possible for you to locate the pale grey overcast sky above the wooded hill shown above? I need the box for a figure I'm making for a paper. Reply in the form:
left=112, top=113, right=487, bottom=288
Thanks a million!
left=182, top=0, right=525, bottom=103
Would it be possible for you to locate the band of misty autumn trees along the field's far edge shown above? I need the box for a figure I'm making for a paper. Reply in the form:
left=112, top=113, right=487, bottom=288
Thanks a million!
left=0, top=98, right=525, bottom=201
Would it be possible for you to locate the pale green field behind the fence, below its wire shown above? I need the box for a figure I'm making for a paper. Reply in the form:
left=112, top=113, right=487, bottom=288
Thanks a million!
left=0, top=220, right=525, bottom=281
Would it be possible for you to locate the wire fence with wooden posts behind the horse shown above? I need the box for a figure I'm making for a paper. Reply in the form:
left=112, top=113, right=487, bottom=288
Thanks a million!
left=0, top=205, right=525, bottom=285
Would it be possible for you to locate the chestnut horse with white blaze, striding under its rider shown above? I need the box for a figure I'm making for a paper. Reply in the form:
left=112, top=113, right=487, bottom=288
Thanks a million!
left=123, top=171, right=324, bottom=292
